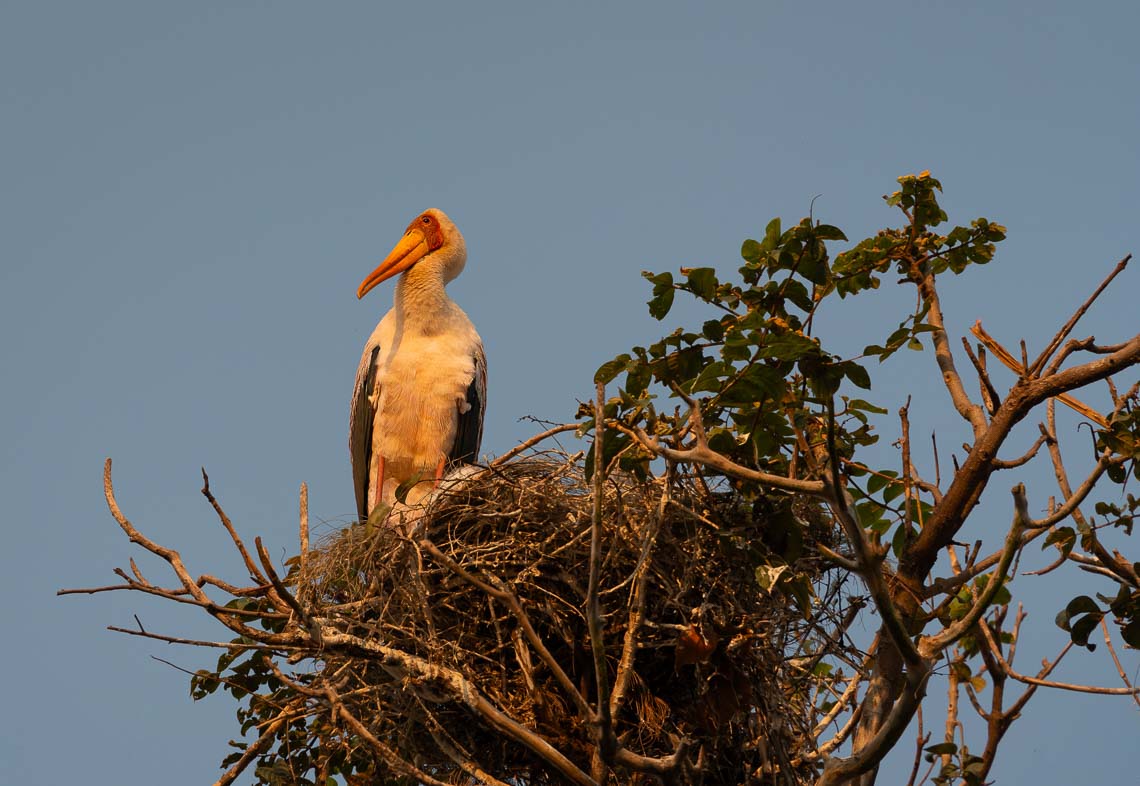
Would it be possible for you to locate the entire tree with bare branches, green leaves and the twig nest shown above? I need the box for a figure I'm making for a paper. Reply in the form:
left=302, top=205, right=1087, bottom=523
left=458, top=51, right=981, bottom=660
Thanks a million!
left=65, top=172, right=1140, bottom=785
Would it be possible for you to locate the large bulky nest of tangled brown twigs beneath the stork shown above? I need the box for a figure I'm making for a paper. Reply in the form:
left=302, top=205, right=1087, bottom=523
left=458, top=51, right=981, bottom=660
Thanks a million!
left=298, top=455, right=834, bottom=784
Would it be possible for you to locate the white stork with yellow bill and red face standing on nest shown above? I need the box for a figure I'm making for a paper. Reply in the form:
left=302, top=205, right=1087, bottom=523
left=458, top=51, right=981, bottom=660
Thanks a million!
left=349, top=208, right=487, bottom=519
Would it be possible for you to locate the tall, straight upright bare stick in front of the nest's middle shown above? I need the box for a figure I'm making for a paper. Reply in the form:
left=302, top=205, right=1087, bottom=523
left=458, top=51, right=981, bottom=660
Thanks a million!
left=586, top=382, right=618, bottom=764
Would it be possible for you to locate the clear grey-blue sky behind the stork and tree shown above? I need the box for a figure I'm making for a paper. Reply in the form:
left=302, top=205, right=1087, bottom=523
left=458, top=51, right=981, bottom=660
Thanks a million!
left=0, top=1, right=1140, bottom=786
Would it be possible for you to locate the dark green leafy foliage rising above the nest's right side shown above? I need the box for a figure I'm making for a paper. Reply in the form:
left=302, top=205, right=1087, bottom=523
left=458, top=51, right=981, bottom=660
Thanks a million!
left=579, top=172, right=1008, bottom=625
